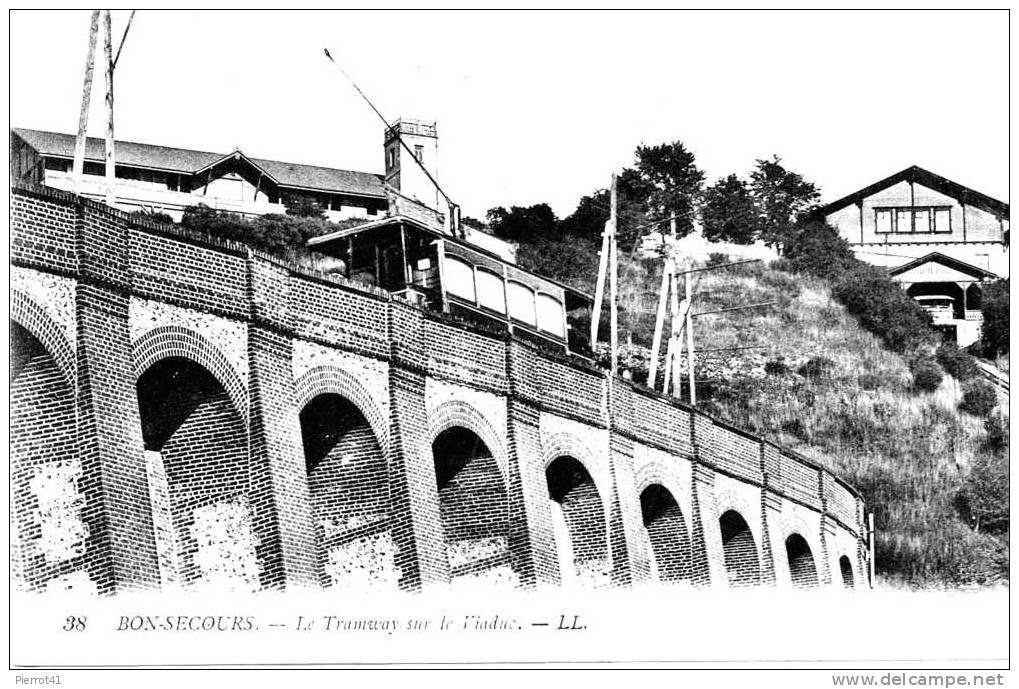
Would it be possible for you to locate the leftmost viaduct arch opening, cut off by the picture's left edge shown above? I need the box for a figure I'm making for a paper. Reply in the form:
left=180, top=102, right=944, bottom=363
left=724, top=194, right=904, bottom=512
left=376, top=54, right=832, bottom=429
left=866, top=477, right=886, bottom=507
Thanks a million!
left=10, top=320, right=88, bottom=592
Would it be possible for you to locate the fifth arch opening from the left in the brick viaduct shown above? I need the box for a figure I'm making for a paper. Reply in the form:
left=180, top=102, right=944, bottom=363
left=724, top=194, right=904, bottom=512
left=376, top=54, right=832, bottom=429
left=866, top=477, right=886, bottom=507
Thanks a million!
left=545, top=456, right=611, bottom=588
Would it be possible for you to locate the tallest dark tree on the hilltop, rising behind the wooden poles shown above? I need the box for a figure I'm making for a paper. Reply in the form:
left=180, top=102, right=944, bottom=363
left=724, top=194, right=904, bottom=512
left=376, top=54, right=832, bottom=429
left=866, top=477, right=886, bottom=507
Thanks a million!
left=635, top=141, right=705, bottom=236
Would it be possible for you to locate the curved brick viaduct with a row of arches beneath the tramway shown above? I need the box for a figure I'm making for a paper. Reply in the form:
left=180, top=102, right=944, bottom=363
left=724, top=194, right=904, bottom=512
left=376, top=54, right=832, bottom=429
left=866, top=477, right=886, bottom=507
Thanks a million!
left=10, top=188, right=867, bottom=594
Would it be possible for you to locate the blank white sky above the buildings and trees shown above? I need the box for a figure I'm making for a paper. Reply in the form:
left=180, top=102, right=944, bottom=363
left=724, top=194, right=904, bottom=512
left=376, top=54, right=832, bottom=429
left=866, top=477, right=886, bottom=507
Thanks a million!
left=10, top=10, right=1009, bottom=217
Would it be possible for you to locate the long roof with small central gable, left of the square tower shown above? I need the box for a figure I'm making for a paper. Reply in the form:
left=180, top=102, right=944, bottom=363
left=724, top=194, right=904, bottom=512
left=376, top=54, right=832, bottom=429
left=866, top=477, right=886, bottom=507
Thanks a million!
left=11, top=128, right=385, bottom=199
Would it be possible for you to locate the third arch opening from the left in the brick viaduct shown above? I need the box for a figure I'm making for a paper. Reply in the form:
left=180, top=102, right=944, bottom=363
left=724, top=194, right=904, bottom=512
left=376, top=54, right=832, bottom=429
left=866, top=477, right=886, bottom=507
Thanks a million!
left=300, top=393, right=399, bottom=590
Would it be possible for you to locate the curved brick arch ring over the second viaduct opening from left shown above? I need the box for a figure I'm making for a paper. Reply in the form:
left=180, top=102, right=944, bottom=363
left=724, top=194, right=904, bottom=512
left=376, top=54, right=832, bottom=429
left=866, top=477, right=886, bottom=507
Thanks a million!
left=132, top=325, right=248, bottom=423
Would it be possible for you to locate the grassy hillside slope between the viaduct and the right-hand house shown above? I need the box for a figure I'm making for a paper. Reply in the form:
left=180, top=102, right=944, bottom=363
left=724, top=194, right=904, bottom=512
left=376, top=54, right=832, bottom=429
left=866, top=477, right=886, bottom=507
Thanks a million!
left=525, top=240, right=1008, bottom=587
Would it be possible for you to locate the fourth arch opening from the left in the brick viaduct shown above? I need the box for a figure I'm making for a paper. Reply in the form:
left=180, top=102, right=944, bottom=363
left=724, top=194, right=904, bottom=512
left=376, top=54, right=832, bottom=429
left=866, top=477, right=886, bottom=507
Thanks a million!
left=432, top=426, right=519, bottom=586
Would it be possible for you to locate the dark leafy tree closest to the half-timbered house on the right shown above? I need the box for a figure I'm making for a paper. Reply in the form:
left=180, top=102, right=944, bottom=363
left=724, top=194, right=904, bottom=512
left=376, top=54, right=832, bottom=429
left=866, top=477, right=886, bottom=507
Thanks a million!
left=750, top=156, right=820, bottom=247
